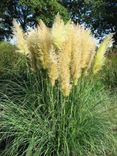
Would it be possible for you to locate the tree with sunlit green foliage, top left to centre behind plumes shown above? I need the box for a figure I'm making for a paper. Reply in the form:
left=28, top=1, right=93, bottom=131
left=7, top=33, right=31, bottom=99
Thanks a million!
left=0, top=0, right=68, bottom=40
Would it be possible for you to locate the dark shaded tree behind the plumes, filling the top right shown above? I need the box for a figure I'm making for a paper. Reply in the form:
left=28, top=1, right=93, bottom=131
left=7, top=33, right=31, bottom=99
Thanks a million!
left=63, top=0, right=117, bottom=44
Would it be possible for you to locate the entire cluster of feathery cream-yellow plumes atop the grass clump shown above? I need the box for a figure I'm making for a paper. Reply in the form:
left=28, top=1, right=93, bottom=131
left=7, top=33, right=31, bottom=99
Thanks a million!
left=14, top=14, right=112, bottom=96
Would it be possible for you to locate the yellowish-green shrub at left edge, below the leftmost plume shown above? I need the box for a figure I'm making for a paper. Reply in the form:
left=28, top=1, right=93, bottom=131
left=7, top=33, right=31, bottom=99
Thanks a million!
left=0, top=42, right=26, bottom=75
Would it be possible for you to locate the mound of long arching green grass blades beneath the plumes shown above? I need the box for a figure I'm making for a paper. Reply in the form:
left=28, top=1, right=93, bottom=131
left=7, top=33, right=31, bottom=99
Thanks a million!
left=0, top=73, right=114, bottom=156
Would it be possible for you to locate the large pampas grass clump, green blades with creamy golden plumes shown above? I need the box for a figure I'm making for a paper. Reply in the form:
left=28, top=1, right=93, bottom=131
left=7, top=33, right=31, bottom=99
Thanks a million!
left=0, top=15, right=116, bottom=156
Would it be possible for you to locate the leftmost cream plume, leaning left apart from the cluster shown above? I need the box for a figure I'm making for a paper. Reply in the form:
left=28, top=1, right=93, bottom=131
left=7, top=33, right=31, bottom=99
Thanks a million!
left=13, top=20, right=29, bottom=55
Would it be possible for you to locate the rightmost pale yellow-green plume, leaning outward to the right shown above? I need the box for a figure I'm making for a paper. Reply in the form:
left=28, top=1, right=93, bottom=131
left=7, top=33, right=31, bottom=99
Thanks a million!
left=93, top=34, right=113, bottom=74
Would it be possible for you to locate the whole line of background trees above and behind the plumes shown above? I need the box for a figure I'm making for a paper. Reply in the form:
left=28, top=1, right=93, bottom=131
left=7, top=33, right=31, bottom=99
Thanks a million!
left=0, top=0, right=117, bottom=45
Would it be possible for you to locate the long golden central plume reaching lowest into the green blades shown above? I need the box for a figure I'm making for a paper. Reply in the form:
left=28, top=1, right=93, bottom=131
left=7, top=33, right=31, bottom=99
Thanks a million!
left=58, top=22, right=72, bottom=96
